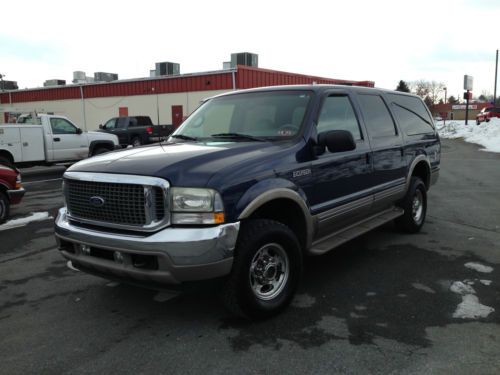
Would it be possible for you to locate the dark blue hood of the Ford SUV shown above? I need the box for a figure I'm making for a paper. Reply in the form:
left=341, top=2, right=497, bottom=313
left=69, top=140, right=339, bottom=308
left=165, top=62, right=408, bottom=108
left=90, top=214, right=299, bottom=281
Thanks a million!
left=68, top=142, right=289, bottom=187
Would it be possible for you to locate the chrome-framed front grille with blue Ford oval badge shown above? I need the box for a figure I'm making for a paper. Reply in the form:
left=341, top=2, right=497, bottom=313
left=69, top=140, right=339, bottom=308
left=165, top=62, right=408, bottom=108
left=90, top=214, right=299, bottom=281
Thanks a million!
left=64, top=172, right=169, bottom=231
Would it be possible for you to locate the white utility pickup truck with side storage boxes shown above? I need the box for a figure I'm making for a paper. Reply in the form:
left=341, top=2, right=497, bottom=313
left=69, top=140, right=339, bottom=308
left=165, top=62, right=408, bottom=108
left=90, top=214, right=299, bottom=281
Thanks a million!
left=0, top=114, right=120, bottom=166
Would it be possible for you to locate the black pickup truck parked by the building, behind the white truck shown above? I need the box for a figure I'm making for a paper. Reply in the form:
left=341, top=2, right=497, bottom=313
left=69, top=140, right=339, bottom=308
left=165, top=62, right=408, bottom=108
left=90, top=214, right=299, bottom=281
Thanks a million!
left=98, top=116, right=174, bottom=147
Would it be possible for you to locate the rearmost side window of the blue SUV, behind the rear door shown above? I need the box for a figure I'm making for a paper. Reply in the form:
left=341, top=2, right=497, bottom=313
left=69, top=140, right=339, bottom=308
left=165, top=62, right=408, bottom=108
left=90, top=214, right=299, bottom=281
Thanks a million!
left=389, top=95, right=434, bottom=135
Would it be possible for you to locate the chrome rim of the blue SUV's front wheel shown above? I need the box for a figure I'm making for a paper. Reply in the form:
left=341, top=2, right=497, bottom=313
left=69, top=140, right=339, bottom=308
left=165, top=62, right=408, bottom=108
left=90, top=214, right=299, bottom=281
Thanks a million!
left=249, top=243, right=290, bottom=301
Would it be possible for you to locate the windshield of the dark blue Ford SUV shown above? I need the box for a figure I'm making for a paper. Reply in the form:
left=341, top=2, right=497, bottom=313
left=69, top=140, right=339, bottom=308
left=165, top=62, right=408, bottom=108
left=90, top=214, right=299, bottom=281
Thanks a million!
left=172, top=90, right=312, bottom=141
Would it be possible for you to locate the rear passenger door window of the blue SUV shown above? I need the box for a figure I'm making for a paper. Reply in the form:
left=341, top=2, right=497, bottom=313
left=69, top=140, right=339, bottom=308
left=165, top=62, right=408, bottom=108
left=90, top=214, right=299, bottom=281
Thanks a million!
left=359, top=95, right=396, bottom=138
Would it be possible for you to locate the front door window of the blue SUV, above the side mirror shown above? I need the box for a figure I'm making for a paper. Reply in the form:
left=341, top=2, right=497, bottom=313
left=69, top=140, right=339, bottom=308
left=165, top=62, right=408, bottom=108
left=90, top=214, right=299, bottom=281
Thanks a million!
left=318, top=95, right=361, bottom=139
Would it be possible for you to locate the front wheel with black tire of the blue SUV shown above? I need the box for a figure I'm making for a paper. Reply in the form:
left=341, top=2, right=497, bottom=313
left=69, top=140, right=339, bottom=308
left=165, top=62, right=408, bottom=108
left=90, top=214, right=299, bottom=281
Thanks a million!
left=222, top=219, right=302, bottom=319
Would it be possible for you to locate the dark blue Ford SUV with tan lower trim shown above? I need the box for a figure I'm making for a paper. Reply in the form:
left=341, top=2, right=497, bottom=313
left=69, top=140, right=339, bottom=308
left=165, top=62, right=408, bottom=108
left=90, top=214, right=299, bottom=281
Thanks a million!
left=55, top=85, right=441, bottom=319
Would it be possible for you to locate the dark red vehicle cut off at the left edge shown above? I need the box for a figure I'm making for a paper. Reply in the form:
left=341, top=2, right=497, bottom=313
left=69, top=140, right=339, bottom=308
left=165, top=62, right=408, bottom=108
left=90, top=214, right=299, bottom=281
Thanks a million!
left=0, top=164, right=24, bottom=224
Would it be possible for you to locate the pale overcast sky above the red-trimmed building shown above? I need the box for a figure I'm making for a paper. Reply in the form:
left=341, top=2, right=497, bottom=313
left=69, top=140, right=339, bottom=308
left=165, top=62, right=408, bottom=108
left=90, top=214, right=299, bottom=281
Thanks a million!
left=0, top=0, right=500, bottom=100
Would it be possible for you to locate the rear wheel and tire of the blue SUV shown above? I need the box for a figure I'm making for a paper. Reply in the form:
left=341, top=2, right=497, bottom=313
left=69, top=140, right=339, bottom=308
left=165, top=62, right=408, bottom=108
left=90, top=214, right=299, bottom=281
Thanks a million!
left=395, top=177, right=427, bottom=233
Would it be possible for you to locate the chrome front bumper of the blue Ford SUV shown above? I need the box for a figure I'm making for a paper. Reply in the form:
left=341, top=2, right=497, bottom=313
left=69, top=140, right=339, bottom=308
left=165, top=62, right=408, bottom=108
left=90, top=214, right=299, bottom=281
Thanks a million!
left=55, top=208, right=240, bottom=284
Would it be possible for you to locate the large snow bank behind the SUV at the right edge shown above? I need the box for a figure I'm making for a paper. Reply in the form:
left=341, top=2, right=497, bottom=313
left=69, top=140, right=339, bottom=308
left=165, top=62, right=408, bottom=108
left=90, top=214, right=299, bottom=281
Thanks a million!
left=436, top=118, right=500, bottom=152
